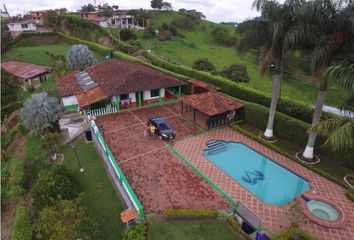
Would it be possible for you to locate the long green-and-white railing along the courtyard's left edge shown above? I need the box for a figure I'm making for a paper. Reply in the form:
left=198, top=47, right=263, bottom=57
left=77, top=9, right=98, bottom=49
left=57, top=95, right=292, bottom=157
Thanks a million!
left=91, top=120, right=145, bottom=218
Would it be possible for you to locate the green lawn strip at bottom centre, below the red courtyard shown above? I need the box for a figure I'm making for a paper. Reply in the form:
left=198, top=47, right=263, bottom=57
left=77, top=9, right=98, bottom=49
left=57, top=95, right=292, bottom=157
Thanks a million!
left=148, top=220, right=243, bottom=240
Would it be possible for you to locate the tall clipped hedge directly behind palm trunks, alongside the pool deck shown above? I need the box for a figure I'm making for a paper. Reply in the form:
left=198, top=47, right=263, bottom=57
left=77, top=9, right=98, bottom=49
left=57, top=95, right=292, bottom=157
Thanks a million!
left=244, top=102, right=354, bottom=168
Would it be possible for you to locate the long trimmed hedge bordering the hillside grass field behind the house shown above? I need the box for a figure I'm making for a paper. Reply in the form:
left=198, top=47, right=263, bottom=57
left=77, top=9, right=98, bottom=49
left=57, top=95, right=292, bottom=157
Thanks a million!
left=143, top=51, right=333, bottom=123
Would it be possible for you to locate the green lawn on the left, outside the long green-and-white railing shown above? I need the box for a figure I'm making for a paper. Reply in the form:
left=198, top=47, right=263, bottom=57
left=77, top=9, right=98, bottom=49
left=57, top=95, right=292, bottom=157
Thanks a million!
left=26, top=137, right=124, bottom=240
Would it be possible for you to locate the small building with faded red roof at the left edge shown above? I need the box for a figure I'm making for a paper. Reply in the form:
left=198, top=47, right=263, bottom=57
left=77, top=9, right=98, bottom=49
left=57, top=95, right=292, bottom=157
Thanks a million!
left=1, top=61, right=50, bottom=87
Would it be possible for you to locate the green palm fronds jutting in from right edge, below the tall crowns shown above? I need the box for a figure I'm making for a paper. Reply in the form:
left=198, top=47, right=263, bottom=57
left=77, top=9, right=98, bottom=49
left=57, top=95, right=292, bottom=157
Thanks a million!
left=311, top=61, right=354, bottom=151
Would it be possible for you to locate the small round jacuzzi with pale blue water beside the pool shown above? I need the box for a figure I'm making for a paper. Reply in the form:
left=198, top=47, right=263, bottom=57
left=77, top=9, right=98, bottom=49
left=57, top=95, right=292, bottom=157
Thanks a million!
left=307, top=200, right=339, bottom=221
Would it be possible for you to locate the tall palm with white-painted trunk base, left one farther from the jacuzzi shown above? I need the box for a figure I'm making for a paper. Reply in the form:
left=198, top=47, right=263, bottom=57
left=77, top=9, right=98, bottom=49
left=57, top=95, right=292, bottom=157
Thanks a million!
left=237, top=0, right=302, bottom=139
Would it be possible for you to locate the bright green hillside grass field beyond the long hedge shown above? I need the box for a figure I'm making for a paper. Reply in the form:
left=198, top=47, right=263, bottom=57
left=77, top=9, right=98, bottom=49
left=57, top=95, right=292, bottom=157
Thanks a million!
left=139, top=12, right=345, bottom=106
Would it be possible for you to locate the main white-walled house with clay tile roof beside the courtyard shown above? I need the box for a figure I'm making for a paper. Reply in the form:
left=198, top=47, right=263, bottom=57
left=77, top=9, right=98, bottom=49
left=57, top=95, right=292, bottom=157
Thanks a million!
left=57, top=59, right=185, bottom=112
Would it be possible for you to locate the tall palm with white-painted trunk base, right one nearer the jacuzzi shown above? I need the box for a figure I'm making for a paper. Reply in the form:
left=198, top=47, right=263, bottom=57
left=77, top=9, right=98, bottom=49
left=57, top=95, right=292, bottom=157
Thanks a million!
left=285, top=0, right=353, bottom=159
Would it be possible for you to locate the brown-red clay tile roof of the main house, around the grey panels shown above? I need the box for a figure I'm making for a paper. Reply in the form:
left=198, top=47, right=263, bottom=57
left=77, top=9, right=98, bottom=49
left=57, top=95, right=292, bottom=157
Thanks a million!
left=57, top=59, right=185, bottom=97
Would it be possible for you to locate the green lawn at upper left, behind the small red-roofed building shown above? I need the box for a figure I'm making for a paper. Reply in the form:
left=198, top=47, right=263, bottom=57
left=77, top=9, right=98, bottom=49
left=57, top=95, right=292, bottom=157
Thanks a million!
left=1, top=43, right=104, bottom=66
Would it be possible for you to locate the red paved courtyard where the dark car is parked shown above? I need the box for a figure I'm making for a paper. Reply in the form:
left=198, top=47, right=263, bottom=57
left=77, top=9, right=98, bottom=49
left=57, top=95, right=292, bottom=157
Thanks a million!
left=96, top=105, right=232, bottom=213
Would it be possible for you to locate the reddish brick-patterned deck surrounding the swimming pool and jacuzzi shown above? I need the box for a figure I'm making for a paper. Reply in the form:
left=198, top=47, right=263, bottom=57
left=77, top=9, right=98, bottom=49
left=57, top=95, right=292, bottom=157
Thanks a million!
left=174, top=127, right=354, bottom=240
